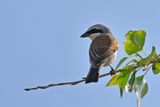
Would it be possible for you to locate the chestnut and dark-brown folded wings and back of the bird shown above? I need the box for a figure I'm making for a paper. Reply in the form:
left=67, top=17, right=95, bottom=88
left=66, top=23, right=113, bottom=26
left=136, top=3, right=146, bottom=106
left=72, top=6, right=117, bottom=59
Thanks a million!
left=89, top=35, right=112, bottom=67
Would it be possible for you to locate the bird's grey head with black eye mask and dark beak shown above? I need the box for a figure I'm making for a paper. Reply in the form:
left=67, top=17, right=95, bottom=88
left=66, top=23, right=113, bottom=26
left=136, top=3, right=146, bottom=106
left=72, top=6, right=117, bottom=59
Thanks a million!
left=81, top=24, right=111, bottom=40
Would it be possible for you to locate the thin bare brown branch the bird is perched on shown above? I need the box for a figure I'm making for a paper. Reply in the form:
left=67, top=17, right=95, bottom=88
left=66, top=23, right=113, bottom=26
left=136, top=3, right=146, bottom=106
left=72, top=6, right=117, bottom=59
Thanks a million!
left=24, top=69, right=120, bottom=91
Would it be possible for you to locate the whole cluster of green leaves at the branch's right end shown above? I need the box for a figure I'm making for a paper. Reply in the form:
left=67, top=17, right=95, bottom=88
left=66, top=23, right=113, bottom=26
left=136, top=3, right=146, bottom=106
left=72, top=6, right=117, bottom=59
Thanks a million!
left=107, top=30, right=160, bottom=99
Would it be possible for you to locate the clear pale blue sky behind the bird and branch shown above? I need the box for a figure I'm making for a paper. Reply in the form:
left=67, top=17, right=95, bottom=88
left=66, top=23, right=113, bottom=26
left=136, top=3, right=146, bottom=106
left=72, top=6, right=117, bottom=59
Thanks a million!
left=0, top=0, right=160, bottom=107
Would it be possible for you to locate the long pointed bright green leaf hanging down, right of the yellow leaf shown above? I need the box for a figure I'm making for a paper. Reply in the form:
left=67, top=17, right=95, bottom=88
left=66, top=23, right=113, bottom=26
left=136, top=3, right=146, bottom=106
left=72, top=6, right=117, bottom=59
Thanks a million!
left=118, top=65, right=133, bottom=97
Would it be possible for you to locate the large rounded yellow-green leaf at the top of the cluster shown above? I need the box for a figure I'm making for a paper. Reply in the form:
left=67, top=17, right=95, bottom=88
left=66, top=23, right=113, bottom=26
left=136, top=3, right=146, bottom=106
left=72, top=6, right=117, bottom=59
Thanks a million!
left=123, top=30, right=146, bottom=55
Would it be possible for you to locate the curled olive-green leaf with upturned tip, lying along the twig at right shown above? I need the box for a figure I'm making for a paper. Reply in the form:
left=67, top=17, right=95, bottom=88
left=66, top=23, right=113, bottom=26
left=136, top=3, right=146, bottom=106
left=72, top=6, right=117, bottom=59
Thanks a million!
left=137, top=46, right=156, bottom=66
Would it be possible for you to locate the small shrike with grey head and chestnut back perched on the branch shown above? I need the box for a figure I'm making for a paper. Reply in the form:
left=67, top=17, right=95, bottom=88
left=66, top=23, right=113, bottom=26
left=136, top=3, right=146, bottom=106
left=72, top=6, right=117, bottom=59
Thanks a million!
left=81, top=24, right=119, bottom=84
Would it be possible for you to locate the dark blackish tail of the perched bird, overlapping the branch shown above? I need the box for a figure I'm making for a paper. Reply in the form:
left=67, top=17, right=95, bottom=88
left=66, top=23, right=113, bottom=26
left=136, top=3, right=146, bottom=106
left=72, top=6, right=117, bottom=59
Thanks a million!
left=85, top=67, right=99, bottom=83
